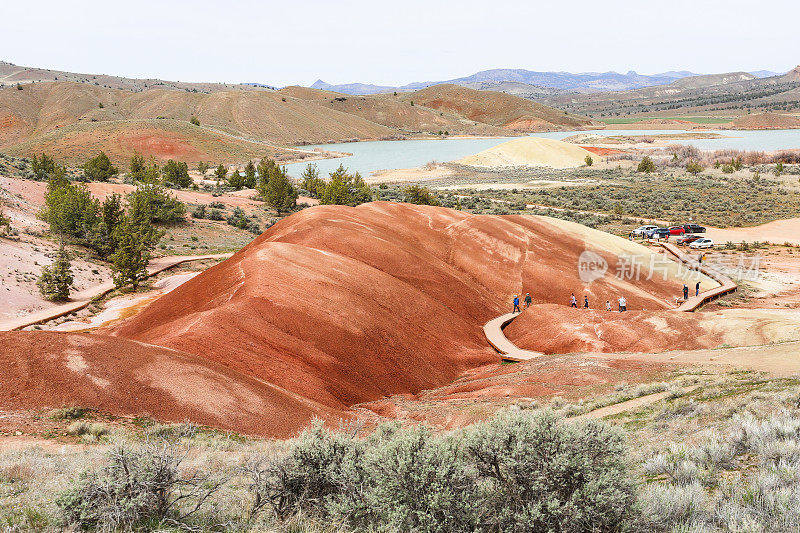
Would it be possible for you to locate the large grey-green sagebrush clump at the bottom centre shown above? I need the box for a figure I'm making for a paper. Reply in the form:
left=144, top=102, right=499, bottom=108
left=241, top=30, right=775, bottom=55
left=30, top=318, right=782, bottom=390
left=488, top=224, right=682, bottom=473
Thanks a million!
left=245, top=412, right=633, bottom=532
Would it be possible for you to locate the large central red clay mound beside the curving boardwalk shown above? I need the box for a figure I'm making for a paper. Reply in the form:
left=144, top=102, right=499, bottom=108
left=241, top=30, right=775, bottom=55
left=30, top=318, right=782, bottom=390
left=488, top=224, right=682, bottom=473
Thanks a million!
left=113, top=202, right=692, bottom=434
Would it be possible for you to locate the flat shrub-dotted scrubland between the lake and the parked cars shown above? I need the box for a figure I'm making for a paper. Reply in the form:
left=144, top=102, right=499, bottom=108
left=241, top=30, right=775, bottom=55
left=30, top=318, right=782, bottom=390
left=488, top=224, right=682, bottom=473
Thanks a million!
left=443, top=153, right=800, bottom=227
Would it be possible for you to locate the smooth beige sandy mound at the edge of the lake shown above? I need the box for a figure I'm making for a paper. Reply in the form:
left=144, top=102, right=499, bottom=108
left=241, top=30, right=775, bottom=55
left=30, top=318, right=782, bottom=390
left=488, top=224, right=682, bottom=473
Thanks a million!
left=456, top=137, right=592, bottom=168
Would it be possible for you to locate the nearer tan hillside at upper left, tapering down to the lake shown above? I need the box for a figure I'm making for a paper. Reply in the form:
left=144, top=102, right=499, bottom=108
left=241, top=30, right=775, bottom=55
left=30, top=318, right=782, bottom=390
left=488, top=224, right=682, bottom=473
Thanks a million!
left=0, top=82, right=395, bottom=161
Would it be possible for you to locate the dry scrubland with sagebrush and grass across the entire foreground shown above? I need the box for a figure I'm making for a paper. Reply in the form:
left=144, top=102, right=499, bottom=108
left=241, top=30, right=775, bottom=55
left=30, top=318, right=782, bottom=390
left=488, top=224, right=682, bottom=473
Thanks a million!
left=0, top=372, right=800, bottom=533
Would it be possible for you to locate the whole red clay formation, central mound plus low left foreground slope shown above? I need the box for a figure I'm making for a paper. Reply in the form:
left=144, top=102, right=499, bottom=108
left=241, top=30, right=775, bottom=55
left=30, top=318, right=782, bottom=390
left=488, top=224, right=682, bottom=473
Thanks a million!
left=0, top=202, right=704, bottom=437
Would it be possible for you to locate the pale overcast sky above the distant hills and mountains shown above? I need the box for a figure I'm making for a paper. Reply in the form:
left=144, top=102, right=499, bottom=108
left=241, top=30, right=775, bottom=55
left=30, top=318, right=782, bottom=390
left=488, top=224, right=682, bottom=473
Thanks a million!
left=0, top=0, right=800, bottom=86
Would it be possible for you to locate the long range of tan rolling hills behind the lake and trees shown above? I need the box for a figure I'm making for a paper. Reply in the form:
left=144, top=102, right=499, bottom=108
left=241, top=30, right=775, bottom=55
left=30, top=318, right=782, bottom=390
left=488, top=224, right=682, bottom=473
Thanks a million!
left=0, top=71, right=591, bottom=164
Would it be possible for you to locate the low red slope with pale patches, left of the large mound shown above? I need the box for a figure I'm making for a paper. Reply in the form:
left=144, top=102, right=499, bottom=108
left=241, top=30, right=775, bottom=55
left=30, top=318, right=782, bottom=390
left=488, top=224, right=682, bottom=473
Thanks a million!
left=0, top=331, right=334, bottom=437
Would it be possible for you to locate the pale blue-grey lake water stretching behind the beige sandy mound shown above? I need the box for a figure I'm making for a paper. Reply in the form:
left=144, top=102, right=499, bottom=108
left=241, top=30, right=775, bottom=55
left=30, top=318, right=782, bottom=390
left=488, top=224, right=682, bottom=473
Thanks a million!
left=286, top=129, right=800, bottom=178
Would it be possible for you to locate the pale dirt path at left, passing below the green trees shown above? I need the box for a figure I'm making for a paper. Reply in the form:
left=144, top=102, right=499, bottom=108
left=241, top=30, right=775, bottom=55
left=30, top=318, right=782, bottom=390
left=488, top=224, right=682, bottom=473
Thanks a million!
left=0, top=254, right=232, bottom=331
